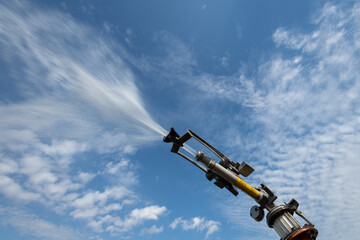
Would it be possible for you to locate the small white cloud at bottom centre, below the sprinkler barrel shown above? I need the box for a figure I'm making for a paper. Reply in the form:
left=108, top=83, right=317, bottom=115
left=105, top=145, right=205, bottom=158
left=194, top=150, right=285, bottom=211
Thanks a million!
left=170, top=217, right=221, bottom=238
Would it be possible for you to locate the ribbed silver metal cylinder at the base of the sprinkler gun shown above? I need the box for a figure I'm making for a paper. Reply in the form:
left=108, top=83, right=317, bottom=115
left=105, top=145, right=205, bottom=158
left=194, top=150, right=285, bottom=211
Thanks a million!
left=273, top=212, right=301, bottom=239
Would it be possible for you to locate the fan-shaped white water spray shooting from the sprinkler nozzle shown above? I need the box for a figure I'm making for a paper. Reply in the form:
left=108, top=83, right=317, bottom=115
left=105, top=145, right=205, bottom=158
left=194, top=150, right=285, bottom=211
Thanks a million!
left=0, top=3, right=167, bottom=147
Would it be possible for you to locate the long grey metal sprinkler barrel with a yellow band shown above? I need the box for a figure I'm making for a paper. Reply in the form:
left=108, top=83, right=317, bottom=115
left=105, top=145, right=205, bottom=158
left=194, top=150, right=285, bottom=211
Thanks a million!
left=195, top=152, right=261, bottom=201
